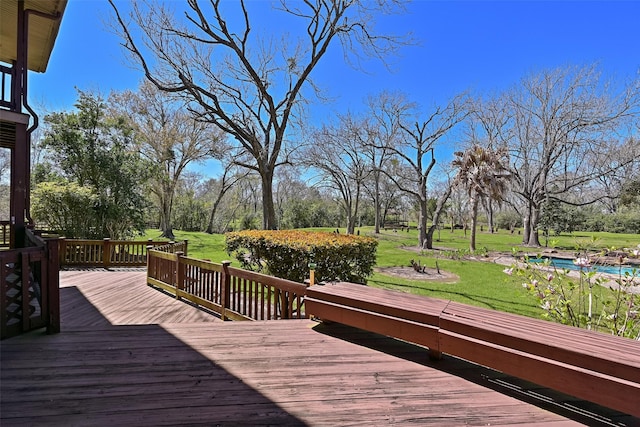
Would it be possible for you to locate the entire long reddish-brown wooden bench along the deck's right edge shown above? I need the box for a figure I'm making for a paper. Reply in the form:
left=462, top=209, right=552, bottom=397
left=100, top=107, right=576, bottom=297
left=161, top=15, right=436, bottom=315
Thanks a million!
left=305, top=283, right=640, bottom=417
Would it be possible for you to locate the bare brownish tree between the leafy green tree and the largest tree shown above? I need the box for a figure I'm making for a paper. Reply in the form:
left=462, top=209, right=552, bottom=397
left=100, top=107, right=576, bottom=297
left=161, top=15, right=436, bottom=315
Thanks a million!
left=110, top=82, right=227, bottom=239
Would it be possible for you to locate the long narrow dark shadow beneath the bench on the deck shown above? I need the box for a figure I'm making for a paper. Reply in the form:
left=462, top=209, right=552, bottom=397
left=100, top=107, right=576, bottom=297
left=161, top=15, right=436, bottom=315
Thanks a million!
left=313, top=322, right=640, bottom=427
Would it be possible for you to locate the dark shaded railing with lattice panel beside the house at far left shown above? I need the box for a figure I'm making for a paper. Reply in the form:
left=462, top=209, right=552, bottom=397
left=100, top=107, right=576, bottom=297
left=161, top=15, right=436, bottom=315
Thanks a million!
left=0, top=230, right=60, bottom=339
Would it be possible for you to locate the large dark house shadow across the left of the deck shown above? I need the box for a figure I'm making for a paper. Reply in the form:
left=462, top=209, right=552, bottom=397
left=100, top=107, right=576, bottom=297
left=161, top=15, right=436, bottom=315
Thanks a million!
left=0, top=287, right=306, bottom=426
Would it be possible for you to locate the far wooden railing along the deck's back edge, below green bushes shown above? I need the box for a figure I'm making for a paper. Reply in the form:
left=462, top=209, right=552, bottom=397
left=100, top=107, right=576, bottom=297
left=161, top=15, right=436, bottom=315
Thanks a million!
left=60, top=239, right=188, bottom=268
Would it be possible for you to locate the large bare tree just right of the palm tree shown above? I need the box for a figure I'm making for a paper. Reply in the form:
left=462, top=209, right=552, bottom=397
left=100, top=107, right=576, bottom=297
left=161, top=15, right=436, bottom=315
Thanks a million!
left=503, top=67, right=640, bottom=246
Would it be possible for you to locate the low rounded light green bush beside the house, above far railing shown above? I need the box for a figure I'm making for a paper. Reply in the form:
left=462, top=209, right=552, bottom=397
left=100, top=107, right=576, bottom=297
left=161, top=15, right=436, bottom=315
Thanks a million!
left=31, top=182, right=103, bottom=239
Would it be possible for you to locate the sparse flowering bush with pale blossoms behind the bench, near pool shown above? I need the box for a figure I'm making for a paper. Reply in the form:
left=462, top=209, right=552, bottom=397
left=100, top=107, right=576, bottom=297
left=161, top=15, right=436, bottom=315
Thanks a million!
left=504, top=245, right=640, bottom=339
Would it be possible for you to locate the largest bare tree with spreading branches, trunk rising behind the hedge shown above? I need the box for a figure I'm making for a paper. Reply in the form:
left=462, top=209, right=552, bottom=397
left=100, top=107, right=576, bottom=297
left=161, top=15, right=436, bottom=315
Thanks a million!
left=109, top=0, right=406, bottom=229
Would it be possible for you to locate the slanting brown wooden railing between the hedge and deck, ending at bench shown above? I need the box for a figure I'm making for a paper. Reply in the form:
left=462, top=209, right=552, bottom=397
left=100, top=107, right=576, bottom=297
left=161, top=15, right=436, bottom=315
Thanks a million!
left=147, top=248, right=307, bottom=320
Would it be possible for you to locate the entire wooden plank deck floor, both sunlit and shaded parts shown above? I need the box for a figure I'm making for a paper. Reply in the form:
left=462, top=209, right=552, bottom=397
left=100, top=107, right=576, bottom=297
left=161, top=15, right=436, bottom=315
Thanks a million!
left=0, top=271, right=639, bottom=426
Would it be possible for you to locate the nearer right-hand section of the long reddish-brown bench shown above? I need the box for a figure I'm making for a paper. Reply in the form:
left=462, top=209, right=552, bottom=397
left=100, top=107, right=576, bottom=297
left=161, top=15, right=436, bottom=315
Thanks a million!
left=438, top=302, right=640, bottom=416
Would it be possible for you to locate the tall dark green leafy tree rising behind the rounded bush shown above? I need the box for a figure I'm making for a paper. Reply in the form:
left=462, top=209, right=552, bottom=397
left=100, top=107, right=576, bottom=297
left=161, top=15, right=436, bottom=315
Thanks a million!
left=40, top=91, right=148, bottom=239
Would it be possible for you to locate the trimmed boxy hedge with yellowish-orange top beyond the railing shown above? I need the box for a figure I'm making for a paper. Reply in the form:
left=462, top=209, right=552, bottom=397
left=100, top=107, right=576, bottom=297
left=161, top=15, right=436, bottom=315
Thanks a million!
left=225, top=230, right=378, bottom=283
